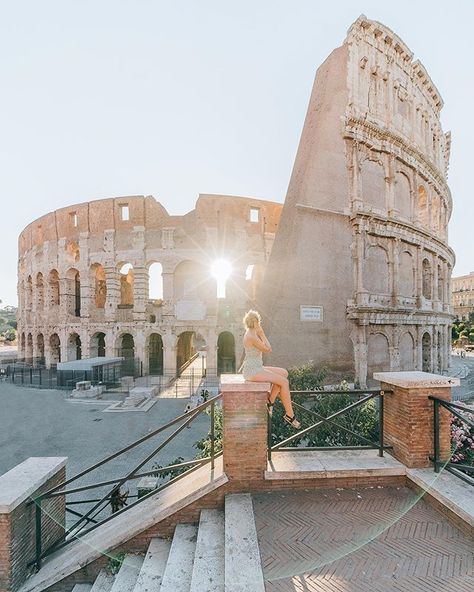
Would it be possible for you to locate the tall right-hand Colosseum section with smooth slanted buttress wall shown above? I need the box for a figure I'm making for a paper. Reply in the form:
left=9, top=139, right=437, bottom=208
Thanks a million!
left=259, top=16, right=454, bottom=385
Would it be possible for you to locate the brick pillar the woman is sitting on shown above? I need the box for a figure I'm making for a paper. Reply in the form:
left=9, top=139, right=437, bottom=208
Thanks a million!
left=220, top=374, right=270, bottom=485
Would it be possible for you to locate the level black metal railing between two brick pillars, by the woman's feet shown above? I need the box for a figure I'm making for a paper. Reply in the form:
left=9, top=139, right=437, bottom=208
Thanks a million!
left=268, top=389, right=391, bottom=459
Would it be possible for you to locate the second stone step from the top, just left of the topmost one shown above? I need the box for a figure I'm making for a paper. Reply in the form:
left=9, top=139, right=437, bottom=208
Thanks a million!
left=190, top=510, right=224, bottom=592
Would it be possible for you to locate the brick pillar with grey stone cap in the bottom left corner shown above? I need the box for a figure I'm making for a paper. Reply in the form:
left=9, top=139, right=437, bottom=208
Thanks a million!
left=0, top=457, right=67, bottom=592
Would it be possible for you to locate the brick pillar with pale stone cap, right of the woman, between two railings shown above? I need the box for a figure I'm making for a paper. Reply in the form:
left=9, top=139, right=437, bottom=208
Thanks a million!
left=374, top=372, right=459, bottom=468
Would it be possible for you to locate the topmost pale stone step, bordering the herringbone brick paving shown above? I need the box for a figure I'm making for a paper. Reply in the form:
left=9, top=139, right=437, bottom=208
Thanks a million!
left=225, top=493, right=265, bottom=592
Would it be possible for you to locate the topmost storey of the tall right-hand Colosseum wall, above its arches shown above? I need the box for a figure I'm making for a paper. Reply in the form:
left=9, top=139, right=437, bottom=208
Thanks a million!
left=345, top=15, right=451, bottom=179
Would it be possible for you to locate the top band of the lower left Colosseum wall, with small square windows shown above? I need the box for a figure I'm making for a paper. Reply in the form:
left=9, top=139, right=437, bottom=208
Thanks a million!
left=18, top=195, right=282, bottom=258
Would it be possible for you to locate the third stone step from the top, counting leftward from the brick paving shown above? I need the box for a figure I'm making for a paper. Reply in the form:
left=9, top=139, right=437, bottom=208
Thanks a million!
left=160, top=524, right=198, bottom=592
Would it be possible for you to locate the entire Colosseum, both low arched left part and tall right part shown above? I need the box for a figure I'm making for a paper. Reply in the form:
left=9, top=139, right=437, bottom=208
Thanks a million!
left=18, top=16, right=454, bottom=386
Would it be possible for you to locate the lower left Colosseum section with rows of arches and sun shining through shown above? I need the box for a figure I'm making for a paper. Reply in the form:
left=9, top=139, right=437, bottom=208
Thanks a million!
left=18, top=195, right=282, bottom=375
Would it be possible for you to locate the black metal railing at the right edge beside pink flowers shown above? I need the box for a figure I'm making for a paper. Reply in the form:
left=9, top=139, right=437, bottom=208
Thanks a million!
left=429, top=396, right=474, bottom=485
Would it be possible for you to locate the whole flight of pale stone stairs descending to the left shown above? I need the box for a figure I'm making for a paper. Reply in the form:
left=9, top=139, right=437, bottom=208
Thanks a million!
left=67, top=493, right=265, bottom=592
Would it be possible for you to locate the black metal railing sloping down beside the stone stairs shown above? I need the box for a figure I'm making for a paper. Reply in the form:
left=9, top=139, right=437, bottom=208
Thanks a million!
left=31, top=394, right=222, bottom=569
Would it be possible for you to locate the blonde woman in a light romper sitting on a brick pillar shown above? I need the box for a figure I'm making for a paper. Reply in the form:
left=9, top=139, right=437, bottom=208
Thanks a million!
left=242, top=310, right=300, bottom=429
